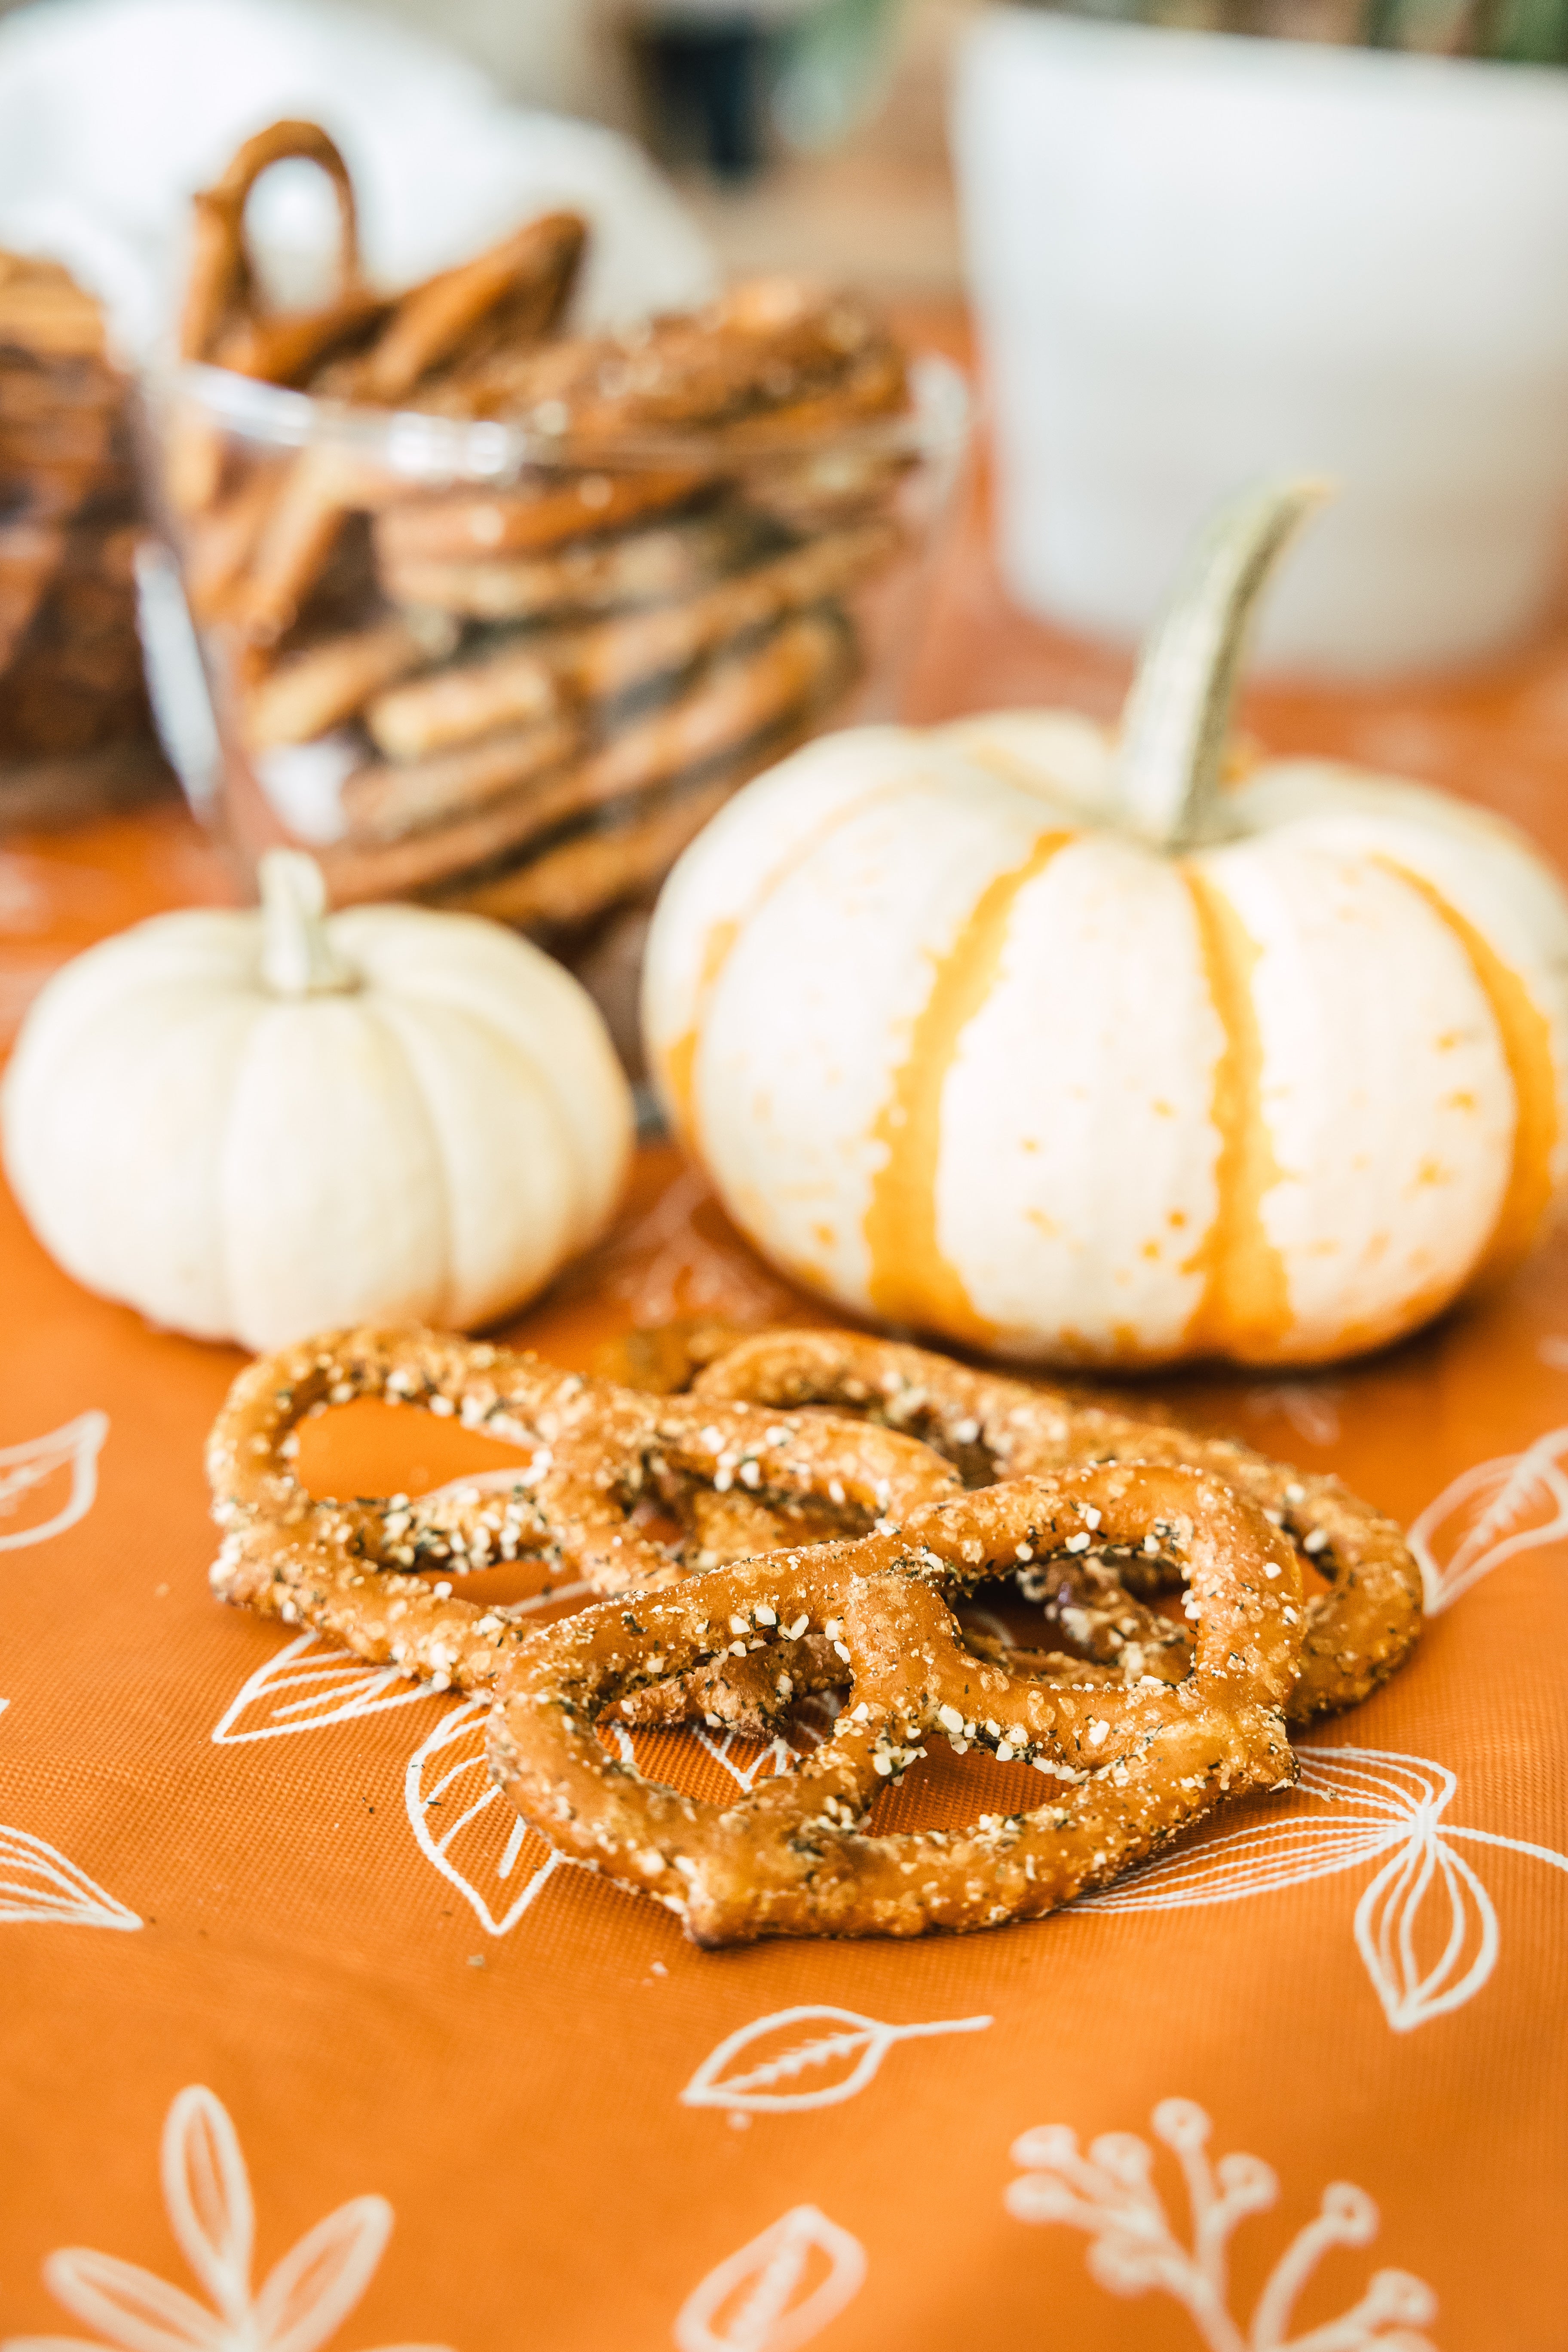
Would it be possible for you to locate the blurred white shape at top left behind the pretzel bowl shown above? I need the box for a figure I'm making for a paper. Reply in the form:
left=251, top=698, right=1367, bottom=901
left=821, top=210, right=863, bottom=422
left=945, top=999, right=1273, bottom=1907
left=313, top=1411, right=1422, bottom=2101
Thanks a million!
left=0, top=0, right=715, bottom=353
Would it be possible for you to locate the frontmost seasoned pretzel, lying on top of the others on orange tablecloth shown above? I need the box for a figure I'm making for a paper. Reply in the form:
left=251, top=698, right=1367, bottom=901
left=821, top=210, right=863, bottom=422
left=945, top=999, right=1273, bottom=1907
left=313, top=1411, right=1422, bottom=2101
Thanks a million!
left=489, top=1463, right=1300, bottom=1948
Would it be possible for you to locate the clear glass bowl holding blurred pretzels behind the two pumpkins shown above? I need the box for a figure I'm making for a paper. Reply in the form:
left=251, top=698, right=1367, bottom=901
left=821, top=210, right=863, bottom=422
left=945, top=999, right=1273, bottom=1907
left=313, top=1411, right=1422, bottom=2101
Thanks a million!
left=141, top=358, right=968, bottom=1042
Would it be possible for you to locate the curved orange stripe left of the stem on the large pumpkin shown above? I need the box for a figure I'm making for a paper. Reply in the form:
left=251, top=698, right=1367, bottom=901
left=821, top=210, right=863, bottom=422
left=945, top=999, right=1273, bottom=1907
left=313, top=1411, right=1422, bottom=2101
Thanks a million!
left=861, top=833, right=1077, bottom=1348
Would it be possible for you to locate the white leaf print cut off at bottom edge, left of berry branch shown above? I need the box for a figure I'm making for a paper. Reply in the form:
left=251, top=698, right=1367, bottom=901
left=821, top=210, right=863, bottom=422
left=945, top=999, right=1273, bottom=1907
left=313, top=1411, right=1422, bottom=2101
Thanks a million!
left=675, top=2206, right=865, bottom=2352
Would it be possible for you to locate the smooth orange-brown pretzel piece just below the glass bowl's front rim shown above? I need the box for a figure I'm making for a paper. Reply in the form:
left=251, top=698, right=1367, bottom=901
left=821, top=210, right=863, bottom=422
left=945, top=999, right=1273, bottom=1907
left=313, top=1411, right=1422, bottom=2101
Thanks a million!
left=379, top=468, right=712, bottom=562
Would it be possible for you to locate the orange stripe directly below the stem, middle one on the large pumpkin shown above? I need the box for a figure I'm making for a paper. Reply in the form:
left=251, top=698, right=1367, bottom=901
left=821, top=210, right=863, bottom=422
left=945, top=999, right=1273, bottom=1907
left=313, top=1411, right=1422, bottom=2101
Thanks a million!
left=1178, top=863, right=1293, bottom=1362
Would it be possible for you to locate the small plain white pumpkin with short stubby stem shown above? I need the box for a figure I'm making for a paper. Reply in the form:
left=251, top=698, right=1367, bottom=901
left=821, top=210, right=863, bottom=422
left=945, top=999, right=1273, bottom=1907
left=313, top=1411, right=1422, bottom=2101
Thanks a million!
left=0, top=851, right=632, bottom=1348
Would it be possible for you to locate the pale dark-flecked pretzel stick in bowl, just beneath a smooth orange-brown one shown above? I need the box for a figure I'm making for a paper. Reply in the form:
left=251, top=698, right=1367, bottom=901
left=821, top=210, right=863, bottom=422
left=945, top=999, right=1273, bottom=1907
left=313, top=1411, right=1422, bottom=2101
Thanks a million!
left=376, top=508, right=760, bottom=621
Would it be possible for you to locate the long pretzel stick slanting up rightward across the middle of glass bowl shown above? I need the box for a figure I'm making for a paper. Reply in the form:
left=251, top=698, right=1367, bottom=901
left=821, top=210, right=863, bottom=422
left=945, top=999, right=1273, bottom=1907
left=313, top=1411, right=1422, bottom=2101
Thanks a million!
left=367, top=522, right=900, bottom=760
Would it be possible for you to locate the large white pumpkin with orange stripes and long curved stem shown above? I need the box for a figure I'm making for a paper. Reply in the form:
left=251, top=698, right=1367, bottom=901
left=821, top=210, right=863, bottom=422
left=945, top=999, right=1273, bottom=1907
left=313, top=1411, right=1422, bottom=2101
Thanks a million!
left=644, top=484, right=1568, bottom=1364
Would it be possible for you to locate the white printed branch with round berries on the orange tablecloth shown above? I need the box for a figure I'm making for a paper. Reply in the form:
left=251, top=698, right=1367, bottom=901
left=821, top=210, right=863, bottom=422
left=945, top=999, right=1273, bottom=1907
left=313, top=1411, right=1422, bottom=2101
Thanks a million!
left=1004, top=2098, right=1436, bottom=2352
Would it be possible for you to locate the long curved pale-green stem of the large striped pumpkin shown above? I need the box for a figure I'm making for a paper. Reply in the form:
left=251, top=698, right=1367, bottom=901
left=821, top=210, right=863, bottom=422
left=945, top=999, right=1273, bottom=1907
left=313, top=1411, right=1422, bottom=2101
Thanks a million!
left=1117, top=475, right=1335, bottom=849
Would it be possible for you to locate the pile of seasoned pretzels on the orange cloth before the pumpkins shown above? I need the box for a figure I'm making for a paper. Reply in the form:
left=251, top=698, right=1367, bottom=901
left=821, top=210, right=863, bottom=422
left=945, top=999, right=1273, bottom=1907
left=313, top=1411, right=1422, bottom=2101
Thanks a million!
left=209, top=1329, right=1422, bottom=1948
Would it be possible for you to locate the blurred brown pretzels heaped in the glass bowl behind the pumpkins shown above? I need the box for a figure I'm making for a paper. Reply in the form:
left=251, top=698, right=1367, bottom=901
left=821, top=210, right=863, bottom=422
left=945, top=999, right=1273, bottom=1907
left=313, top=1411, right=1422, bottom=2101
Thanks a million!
left=165, top=122, right=910, bottom=943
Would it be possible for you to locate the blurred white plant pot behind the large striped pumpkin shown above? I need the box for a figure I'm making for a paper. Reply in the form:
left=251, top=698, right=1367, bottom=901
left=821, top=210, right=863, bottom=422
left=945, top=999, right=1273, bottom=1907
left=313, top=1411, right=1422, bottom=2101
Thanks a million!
left=955, top=7, right=1568, bottom=675
